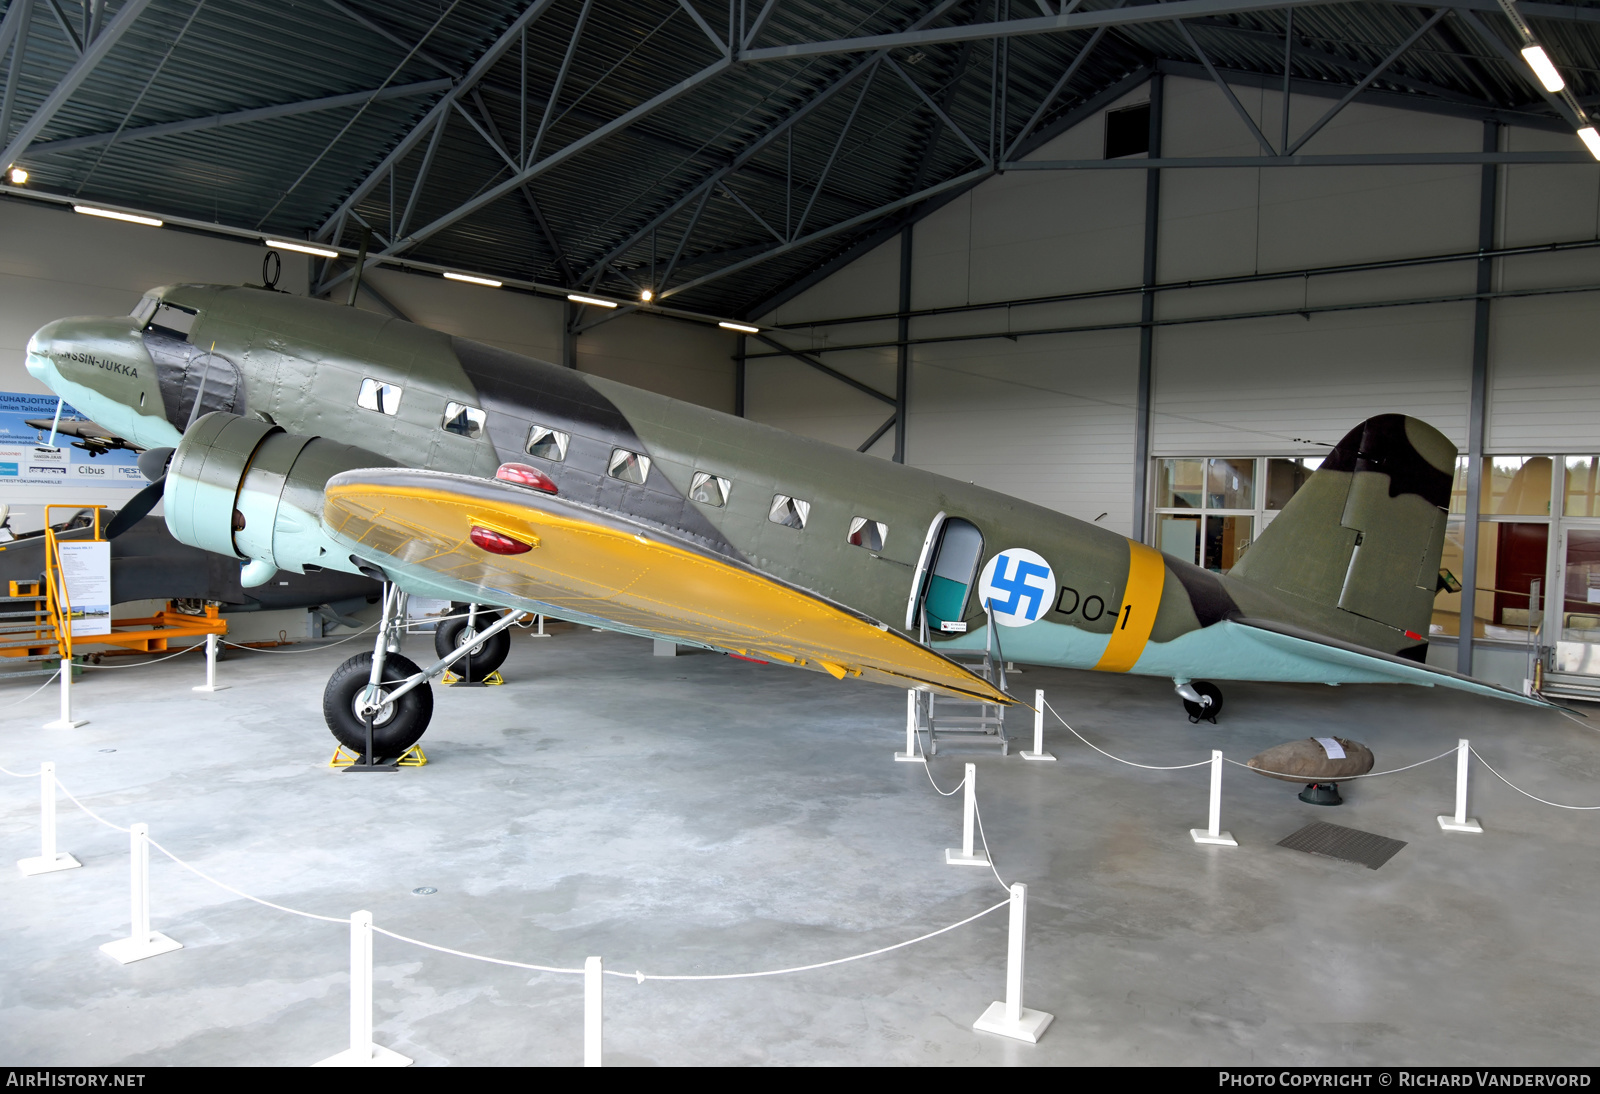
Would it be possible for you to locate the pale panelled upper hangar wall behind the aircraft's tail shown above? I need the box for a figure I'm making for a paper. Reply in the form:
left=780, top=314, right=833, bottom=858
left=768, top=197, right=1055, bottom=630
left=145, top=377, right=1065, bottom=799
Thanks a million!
left=747, top=78, right=1600, bottom=531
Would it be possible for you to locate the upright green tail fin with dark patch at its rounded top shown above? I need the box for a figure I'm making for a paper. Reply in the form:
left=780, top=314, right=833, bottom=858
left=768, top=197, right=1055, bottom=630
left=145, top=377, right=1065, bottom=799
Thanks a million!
left=1229, top=414, right=1456, bottom=635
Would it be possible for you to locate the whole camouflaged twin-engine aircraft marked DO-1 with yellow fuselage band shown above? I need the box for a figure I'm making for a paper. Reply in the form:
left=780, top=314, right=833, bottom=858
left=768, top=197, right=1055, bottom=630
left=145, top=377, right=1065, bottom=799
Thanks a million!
left=27, top=285, right=1533, bottom=757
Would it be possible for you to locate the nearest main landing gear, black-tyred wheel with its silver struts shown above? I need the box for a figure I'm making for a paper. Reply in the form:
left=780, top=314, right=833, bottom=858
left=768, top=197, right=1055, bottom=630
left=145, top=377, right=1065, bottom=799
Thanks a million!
left=322, top=582, right=525, bottom=771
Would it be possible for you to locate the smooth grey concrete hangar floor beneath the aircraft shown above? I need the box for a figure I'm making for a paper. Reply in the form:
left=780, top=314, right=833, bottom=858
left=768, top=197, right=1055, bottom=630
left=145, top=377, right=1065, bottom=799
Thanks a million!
left=0, top=630, right=1600, bottom=1067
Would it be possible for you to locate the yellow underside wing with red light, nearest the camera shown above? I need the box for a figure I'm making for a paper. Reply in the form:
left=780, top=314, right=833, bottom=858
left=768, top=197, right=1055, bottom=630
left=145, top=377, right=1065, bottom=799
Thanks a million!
left=323, top=467, right=1014, bottom=704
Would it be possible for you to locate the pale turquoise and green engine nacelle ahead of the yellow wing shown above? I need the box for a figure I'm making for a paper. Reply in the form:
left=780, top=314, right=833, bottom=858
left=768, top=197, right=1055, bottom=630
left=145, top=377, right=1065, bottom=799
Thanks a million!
left=162, top=411, right=394, bottom=585
